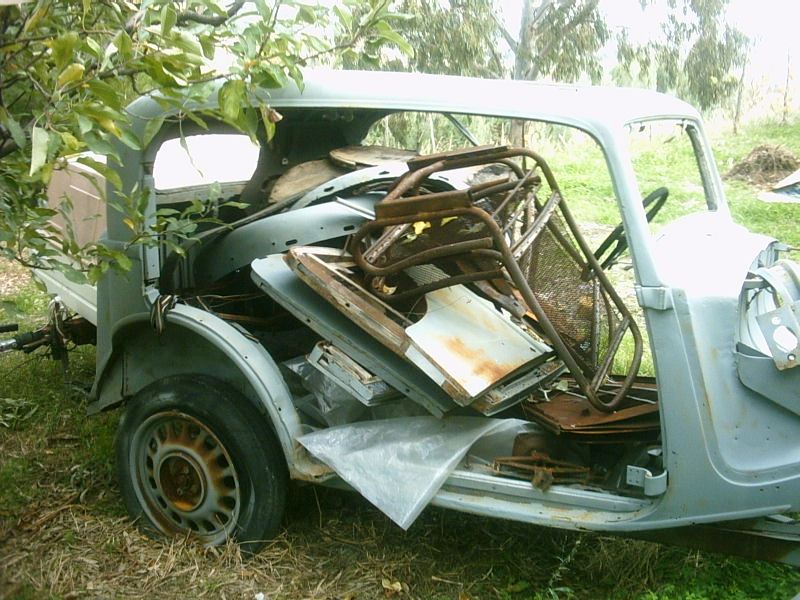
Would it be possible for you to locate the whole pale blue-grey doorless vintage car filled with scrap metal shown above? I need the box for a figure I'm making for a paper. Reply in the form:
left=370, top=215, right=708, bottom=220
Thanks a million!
left=25, top=71, right=800, bottom=564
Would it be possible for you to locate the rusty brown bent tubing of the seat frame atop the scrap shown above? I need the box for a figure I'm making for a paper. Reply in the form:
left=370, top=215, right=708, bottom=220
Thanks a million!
left=352, top=148, right=642, bottom=412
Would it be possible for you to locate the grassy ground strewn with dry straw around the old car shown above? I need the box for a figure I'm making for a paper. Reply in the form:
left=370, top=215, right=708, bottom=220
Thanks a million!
left=0, top=119, right=800, bottom=600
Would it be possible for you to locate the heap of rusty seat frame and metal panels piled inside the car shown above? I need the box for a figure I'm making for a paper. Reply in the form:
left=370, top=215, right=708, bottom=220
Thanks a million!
left=253, top=146, right=659, bottom=500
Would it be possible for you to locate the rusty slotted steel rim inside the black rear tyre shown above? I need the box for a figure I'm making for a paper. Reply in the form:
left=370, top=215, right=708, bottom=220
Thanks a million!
left=130, top=411, right=242, bottom=544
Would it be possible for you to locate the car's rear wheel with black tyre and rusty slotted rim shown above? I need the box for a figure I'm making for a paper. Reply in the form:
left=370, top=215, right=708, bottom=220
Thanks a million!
left=115, top=375, right=288, bottom=553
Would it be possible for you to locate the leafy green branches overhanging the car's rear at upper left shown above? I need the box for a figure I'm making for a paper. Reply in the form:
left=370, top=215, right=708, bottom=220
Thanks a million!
left=0, top=0, right=398, bottom=278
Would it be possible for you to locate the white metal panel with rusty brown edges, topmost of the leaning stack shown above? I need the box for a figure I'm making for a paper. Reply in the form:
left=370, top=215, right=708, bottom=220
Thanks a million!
left=286, top=247, right=550, bottom=409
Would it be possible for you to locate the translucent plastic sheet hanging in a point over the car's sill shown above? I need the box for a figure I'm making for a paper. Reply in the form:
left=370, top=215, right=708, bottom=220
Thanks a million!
left=298, top=416, right=528, bottom=529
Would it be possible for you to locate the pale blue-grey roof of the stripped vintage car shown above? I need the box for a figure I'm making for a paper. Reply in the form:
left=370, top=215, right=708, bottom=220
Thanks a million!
left=129, top=69, right=699, bottom=136
